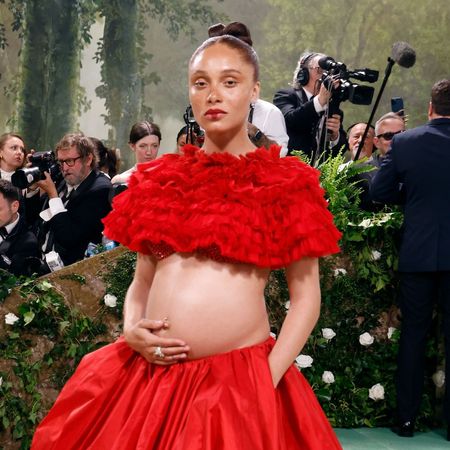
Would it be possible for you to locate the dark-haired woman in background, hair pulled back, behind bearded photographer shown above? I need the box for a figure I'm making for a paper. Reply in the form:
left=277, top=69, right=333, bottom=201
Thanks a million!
left=111, top=121, right=161, bottom=184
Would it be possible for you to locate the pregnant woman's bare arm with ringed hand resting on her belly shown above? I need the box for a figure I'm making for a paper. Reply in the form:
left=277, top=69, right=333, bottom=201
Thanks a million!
left=123, top=253, right=189, bottom=365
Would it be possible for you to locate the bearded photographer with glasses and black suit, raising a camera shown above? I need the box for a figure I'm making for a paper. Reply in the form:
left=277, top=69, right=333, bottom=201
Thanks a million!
left=27, top=133, right=112, bottom=268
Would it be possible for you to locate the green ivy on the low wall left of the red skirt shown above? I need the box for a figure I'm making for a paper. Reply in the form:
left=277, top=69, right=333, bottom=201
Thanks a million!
left=0, top=274, right=110, bottom=449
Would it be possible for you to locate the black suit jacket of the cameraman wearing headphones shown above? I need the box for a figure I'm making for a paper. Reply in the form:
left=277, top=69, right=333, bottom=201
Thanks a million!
left=273, top=88, right=347, bottom=156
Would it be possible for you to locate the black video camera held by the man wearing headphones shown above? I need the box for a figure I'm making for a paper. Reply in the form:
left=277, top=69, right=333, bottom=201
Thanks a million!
left=318, top=56, right=379, bottom=112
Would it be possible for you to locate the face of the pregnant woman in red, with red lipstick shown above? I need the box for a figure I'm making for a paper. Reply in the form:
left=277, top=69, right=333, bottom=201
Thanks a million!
left=189, top=43, right=259, bottom=136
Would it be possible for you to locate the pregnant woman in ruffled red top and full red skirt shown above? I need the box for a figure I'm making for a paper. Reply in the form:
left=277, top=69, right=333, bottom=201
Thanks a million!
left=32, top=36, right=340, bottom=450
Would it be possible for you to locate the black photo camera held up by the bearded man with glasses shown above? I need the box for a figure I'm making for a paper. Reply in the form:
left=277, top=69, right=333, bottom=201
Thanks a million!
left=11, top=151, right=61, bottom=189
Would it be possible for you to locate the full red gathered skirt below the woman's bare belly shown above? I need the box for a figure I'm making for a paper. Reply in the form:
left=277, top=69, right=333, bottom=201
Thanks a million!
left=31, top=338, right=341, bottom=450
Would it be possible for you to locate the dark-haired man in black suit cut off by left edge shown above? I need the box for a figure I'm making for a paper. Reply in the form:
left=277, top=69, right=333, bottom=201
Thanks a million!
left=0, top=180, right=41, bottom=276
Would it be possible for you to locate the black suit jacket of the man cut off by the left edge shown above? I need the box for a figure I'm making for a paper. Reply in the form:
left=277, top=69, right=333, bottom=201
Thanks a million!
left=0, top=216, right=41, bottom=276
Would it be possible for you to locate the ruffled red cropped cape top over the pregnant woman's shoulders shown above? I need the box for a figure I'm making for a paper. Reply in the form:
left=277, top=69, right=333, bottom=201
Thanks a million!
left=103, top=145, right=341, bottom=268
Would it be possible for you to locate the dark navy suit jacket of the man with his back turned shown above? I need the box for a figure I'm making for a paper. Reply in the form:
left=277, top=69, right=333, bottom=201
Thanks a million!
left=371, top=118, right=450, bottom=272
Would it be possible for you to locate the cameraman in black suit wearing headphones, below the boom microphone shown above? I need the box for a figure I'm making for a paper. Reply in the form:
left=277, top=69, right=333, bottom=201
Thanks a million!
left=273, top=52, right=346, bottom=158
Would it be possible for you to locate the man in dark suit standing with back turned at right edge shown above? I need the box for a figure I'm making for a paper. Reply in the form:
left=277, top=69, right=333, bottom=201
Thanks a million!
left=371, top=80, right=450, bottom=438
